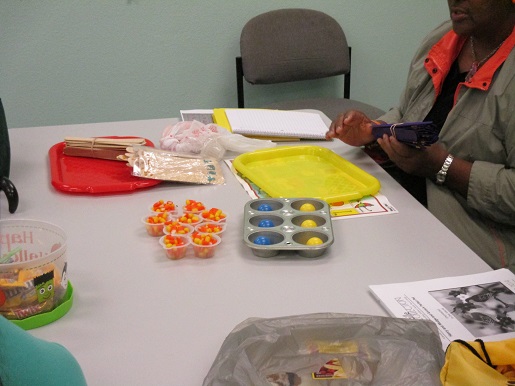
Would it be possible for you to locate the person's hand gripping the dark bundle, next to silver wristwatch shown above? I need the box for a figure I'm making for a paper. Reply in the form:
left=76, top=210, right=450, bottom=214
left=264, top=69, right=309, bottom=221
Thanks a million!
left=377, top=134, right=449, bottom=177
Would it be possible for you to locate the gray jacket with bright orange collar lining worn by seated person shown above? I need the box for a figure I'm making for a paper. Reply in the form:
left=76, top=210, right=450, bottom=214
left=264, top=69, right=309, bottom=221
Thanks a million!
left=379, top=21, right=515, bottom=272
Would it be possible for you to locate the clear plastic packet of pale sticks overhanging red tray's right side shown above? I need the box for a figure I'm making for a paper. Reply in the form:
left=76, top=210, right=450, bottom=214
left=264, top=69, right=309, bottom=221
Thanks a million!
left=126, top=146, right=225, bottom=185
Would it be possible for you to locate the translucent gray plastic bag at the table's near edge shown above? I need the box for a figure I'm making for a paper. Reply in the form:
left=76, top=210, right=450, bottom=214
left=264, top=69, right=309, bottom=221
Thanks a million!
left=203, top=313, right=444, bottom=386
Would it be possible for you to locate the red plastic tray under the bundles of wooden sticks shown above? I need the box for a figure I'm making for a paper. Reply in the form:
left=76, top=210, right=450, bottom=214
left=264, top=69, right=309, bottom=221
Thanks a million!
left=48, top=136, right=162, bottom=194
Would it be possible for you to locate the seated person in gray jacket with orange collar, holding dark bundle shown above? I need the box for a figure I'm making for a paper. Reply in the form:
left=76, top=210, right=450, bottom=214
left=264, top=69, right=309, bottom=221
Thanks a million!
left=327, top=0, right=515, bottom=272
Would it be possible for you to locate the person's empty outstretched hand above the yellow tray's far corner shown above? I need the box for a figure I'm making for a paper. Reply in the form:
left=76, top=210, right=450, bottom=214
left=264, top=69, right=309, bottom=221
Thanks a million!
left=325, top=110, right=375, bottom=146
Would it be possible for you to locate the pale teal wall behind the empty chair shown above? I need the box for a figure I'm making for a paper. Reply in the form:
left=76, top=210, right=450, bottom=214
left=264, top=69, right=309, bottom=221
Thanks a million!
left=0, top=0, right=448, bottom=127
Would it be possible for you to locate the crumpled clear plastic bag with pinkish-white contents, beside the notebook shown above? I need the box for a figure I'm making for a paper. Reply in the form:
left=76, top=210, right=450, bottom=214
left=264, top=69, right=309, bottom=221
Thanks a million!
left=159, top=121, right=276, bottom=160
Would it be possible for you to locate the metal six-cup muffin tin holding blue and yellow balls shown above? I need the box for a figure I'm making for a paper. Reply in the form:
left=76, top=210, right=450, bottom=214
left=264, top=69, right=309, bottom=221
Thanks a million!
left=243, top=198, right=334, bottom=258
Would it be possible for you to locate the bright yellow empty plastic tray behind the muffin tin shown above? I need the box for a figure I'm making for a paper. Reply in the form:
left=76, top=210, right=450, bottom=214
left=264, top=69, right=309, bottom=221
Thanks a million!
left=233, top=146, right=381, bottom=203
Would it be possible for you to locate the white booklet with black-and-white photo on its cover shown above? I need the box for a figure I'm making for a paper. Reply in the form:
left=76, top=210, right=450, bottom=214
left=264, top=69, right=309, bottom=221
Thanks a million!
left=369, top=268, right=515, bottom=350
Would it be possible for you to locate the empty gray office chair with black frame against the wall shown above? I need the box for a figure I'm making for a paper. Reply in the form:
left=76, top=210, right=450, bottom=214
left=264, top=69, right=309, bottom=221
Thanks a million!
left=236, top=9, right=384, bottom=120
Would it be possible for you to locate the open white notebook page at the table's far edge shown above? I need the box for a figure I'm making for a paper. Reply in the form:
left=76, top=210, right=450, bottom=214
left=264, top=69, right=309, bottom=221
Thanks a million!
left=215, top=109, right=328, bottom=139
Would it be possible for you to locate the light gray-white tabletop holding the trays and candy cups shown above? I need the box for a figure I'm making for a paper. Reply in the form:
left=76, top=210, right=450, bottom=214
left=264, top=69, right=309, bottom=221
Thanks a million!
left=0, top=119, right=490, bottom=386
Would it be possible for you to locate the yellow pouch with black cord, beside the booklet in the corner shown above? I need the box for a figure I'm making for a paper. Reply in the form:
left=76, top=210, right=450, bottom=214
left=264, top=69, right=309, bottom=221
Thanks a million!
left=440, top=339, right=515, bottom=386
